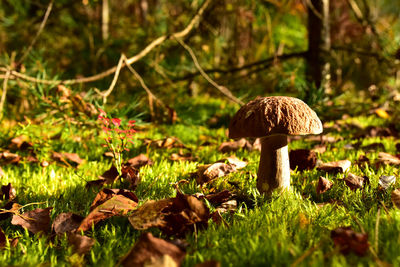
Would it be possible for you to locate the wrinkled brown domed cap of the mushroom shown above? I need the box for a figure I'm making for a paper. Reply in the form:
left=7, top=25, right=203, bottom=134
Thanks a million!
left=229, top=96, right=323, bottom=138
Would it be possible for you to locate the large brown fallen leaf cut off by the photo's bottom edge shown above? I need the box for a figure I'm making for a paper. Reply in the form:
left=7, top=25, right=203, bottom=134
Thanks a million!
left=120, top=233, right=186, bottom=267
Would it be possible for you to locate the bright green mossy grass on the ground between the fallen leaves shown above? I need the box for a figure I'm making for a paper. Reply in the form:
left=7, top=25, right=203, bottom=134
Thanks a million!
left=0, top=101, right=400, bottom=266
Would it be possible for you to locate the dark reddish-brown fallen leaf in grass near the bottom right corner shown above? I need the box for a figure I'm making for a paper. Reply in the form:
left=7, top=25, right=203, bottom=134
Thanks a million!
left=331, top=227, right=369, bottom=256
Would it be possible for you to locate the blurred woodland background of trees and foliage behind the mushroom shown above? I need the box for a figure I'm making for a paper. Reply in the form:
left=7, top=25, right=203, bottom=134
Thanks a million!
left=0, top=0, right=400, bottom=124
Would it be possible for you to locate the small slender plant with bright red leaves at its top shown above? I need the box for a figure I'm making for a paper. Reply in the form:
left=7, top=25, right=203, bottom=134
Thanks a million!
left=98, top=109, right=136, bottom=175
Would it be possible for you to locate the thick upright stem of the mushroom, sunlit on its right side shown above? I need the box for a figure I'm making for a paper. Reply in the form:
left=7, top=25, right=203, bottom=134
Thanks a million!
left=257, top=134, right=290, bottom=194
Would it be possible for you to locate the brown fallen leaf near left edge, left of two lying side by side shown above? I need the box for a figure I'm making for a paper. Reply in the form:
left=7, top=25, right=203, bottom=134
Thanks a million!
left=11, top=207, right=53, bottom=234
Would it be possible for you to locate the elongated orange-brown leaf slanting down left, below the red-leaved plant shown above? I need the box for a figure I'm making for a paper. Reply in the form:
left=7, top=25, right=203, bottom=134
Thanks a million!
left=78, top=195, right=137, bottom=231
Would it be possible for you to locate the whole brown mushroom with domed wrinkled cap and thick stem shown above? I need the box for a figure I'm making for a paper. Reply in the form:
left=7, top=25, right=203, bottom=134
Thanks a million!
left=229, top=96, right=323, bottom=195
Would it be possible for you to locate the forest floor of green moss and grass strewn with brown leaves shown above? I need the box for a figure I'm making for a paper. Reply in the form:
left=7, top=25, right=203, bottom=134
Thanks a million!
left=0, top=95, right=400, bottom=266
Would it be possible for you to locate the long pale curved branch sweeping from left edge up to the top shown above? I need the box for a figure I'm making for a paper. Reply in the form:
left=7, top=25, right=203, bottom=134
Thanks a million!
left=0, top=0, right=211, bottom=85
